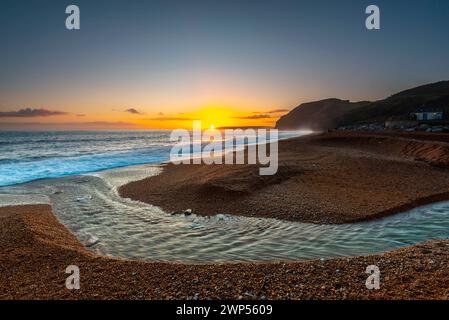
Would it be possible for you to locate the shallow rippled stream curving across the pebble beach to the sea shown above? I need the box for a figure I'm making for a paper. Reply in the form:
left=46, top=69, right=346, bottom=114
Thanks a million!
left=0, top=165, right=449, bottom=263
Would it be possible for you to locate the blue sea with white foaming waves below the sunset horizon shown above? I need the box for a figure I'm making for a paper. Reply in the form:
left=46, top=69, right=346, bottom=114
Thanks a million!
left=0, top=131, right=307, bottom=186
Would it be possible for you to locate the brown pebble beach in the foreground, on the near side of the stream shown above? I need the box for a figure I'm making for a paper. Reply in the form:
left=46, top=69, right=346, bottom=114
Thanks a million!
left=0, top=205, right=449, bottom=300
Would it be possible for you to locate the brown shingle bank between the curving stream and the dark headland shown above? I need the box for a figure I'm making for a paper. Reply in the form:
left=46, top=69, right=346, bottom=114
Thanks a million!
left=120, top=132, right=449, bottom=224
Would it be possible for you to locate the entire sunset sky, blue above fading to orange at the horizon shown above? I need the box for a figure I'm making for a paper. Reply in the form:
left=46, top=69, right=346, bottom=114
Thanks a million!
left=0, top=0, right=449, bottom=130
